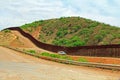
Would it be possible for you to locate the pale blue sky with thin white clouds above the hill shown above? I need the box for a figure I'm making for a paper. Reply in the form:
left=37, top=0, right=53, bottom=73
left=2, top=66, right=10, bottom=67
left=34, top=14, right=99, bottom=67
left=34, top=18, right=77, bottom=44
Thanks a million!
left=0, top=0, right=120, bottom=30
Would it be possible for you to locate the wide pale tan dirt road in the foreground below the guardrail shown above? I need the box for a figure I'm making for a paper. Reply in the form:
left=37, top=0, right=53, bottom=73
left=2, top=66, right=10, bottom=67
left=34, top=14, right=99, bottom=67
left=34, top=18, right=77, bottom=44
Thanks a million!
left=0, top=47, right=120, bottom=80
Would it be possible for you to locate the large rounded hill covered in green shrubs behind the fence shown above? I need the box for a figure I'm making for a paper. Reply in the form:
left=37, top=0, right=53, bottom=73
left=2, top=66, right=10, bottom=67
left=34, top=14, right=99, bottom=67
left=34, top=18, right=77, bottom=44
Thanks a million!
left=21, top=17, right=120, bottom=47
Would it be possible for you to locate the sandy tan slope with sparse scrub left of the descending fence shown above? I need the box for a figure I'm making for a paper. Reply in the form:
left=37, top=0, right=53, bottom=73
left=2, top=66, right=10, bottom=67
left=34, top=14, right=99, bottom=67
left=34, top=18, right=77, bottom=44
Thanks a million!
left=0, top=29, right=37, bottom=48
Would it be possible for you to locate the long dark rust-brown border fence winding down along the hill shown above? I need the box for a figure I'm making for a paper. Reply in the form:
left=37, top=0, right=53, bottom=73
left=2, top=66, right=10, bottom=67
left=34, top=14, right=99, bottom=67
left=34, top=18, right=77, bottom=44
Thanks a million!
left=7, top=27, right=120, bottom=58
